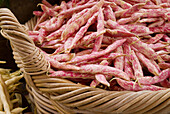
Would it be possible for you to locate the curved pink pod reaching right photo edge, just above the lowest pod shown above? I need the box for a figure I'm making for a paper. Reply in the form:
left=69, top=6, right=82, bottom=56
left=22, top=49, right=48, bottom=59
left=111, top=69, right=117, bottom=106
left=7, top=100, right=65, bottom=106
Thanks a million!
left=138, top=68, right=170, bottom=85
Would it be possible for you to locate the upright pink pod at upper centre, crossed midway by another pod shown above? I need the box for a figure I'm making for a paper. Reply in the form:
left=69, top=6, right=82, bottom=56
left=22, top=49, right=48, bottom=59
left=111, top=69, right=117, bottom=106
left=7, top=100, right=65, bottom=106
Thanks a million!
left=93, top=8, right=104, bottom=52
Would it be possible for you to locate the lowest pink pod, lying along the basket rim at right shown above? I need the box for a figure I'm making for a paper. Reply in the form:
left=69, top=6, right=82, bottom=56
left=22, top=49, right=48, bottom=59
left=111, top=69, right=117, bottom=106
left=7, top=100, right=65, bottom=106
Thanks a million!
left=116, top=78, right=166, bottom=91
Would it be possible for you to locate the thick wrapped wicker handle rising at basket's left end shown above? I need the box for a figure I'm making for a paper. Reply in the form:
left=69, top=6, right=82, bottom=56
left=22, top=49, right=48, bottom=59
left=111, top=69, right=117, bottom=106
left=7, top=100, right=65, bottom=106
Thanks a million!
left=0, top=8, right=50, bottom=75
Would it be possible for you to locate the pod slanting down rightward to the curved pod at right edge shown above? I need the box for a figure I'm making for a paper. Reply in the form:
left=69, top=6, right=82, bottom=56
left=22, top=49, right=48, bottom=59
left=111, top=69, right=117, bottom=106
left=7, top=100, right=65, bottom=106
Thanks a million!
left=136, top=52, right=159, bottom=76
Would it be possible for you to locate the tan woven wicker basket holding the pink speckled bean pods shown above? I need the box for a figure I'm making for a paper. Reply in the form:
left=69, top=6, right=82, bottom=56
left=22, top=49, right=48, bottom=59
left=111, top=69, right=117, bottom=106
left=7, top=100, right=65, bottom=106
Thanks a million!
left=0, top=8, right=170, bottom=114
